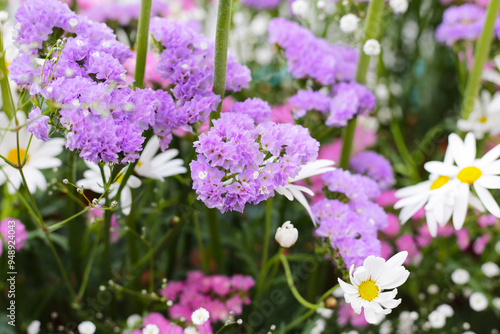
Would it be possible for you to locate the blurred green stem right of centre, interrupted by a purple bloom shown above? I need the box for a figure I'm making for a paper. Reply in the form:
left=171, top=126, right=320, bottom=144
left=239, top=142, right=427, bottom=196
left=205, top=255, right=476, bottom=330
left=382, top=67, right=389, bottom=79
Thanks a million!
left=339, top=0, right=384, bottom=169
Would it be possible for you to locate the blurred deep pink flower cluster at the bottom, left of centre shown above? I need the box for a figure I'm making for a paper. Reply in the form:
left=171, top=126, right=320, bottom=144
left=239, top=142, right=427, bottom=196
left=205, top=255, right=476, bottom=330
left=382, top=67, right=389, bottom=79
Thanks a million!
left=161, top=271, right=255, bottom=324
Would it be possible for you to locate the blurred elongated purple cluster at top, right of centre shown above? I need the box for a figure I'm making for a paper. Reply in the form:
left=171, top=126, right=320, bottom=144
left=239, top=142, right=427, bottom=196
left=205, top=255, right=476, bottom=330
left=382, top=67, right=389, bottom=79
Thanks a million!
left=269, top=18, right=358, bottom=85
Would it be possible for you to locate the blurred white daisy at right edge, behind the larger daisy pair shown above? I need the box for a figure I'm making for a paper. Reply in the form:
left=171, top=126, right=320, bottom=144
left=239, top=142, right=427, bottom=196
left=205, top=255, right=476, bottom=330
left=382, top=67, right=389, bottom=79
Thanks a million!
left=457, top=90, right=500, bottom=139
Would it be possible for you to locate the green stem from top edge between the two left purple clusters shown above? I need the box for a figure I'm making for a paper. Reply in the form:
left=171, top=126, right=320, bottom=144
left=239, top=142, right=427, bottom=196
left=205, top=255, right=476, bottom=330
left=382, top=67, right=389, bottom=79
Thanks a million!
left=134, top=0, right=151, bottom=88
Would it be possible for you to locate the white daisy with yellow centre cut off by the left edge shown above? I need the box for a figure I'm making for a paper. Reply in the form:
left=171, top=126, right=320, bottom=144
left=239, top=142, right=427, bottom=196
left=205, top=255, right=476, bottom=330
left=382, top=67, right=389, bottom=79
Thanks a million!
left=0, top=112, right=64, bottom=194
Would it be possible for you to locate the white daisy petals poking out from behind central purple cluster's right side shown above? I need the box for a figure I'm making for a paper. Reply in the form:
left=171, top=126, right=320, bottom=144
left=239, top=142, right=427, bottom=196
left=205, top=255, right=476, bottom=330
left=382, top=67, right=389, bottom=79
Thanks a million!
left=276, top=159, right=335, bottom=225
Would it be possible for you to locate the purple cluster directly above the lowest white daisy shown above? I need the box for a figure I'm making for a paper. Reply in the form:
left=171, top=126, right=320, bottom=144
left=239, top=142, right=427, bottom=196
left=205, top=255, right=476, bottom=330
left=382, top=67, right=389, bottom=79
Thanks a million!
left=311, top=199, right=381, bottom=267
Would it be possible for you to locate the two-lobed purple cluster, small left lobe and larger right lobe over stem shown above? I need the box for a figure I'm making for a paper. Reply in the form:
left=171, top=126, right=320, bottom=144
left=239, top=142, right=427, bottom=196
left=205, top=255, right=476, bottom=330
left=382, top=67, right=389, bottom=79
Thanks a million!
left=289, top=82, right=375, bottom=127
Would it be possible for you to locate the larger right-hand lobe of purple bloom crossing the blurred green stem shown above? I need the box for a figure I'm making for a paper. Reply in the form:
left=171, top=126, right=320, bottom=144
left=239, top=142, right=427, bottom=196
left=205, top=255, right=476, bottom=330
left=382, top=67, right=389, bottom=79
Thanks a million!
left=326, top=82, right=375, bottom=127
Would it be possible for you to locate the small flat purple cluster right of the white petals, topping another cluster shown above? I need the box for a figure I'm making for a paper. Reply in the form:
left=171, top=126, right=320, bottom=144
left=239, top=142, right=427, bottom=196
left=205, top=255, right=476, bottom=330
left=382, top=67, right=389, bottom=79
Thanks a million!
left=322, top=168, right=380, bottom=200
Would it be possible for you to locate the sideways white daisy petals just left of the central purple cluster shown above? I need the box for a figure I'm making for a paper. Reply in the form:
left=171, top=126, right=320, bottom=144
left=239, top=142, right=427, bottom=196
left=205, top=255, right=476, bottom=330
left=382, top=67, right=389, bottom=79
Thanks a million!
left=134, top=136, right=187, bottom=181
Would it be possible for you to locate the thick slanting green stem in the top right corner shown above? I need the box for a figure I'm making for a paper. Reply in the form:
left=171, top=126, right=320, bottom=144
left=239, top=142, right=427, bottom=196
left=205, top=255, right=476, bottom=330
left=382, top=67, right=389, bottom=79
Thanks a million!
left=461, top=0, right=500, bottom=119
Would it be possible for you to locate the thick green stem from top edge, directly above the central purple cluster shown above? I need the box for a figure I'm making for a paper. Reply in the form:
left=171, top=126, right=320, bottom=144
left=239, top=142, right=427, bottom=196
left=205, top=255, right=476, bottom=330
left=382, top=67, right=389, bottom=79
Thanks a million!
left=211, top=0, right=233, bottom=119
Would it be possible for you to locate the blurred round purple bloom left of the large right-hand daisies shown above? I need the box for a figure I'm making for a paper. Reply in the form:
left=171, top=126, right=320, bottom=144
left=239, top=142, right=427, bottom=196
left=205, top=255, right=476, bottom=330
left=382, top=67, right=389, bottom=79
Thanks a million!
left=350, top=151, right=395, bottom=191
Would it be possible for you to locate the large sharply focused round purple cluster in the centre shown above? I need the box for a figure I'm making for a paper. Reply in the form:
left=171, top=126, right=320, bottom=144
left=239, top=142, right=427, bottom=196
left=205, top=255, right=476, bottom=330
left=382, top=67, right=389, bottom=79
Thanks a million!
left=190, top=112, right=319, bottom=213
